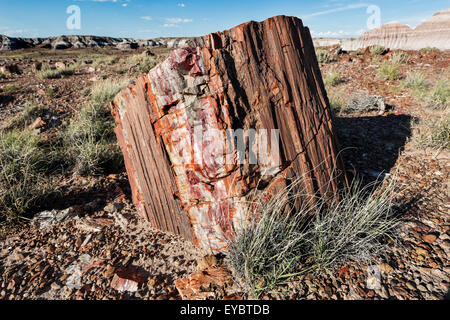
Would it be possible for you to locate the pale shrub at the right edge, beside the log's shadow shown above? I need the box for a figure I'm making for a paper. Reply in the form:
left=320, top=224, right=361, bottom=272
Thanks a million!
left=412, top=110, right=450, bottom=150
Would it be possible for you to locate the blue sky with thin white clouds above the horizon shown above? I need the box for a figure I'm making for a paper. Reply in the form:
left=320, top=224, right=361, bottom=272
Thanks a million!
left=0, top=0, right=450, bottom=39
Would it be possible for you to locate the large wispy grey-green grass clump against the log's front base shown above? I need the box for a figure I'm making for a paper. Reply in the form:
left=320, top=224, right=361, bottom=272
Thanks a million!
left=228, top=181, right=398, bottom=298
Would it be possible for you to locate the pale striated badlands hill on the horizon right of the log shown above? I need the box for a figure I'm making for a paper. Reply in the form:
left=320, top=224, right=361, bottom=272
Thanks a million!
left=342, top=9, right=450, bottom=50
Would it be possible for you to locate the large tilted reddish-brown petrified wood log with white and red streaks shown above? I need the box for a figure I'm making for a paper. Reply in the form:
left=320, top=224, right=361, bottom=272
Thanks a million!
left=111, top=16, right=346, bottom=252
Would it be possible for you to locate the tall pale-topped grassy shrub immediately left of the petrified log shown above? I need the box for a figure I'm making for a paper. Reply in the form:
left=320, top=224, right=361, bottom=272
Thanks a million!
left=64, top=80, right=128, bottom=175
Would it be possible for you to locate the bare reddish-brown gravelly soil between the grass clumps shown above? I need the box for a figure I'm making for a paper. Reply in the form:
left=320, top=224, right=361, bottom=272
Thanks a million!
left=0, top=45, right=450, bottom=300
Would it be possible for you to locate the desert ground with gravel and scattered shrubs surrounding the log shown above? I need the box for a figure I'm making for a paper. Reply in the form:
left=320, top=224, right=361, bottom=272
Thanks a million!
left=0, top=47, right=450, bottom=300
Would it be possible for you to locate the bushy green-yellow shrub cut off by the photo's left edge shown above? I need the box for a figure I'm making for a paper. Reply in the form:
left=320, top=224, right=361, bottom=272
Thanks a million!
left=0, top=130, right=51, bottom=219
